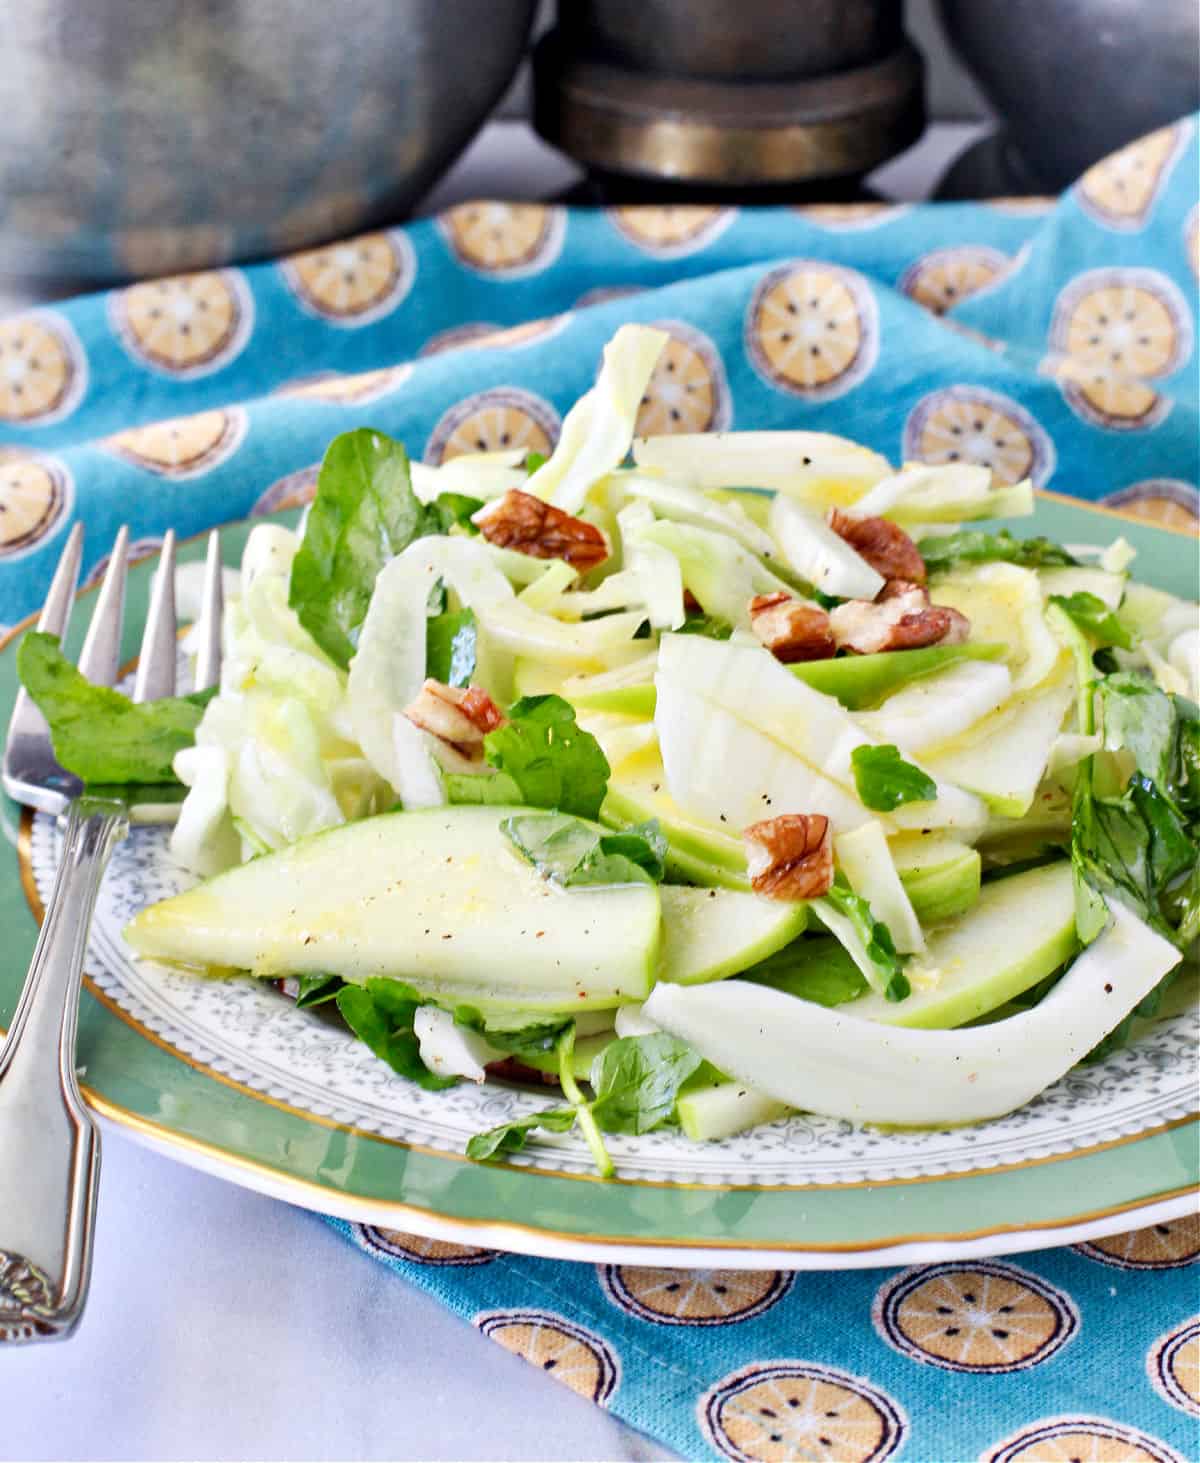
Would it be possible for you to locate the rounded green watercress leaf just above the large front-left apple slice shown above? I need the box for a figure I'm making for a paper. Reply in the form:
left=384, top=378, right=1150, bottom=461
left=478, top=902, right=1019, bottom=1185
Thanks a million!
left=483, top=695, right=610, bottom=818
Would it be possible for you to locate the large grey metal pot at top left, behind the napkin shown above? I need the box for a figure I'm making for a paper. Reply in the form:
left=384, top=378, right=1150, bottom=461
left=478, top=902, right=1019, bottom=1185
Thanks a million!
left=0, top=0, right=536, bottom=282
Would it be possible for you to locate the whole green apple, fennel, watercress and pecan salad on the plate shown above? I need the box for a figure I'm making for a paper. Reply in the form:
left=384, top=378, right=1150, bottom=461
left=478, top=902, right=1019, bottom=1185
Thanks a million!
left=19, top=326, right=1200, bottom=1175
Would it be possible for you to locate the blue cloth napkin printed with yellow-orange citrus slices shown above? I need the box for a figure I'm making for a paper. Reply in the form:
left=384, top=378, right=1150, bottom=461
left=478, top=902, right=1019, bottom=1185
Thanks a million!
left=0, top=120, right=1200, bottom=1463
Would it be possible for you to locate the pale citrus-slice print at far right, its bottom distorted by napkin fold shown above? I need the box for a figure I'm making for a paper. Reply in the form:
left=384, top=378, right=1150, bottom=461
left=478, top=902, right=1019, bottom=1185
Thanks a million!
left=1043, top=269, right=1191, bottom=430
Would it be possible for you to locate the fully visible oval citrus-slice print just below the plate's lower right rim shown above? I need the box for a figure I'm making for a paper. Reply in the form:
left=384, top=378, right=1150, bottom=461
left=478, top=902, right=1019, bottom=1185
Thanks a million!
left=871, top=1260, right=1079, bottom=1372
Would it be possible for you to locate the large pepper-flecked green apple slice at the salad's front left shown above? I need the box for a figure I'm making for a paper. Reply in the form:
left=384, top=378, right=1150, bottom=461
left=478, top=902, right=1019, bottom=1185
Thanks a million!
left=124, top=806, right=661, bottom=1012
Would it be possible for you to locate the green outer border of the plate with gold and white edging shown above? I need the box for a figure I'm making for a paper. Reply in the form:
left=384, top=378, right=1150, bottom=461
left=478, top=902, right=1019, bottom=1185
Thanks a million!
left=0, top=493, right=1200, bottom=1267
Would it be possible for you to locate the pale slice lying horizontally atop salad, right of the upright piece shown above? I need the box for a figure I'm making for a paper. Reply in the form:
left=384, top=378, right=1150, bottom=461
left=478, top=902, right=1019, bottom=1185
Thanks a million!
left=634, top=432, right=891, bottom=506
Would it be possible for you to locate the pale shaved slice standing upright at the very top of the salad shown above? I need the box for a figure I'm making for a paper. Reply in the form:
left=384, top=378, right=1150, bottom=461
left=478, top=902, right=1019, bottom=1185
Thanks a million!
left=524, top=325, right=669, bottom=514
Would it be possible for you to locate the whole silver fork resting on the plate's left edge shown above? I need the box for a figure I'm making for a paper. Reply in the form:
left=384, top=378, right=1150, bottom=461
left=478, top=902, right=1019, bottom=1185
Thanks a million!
left=0, top=524, right=221, bottom=1342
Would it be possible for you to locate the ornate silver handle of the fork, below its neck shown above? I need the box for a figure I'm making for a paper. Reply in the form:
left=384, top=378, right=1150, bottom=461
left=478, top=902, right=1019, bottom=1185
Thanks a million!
left=0, top=796, right=127, bottom=1343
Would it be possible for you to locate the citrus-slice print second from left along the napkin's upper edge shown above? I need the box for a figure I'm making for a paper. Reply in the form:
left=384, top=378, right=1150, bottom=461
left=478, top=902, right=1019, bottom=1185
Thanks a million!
left=108, top=269, right=255, bottom=379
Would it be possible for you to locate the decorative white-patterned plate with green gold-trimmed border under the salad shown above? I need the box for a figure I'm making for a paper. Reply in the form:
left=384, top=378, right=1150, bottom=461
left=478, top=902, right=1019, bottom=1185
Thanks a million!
left=0, top=494, right=1200, bottom=1268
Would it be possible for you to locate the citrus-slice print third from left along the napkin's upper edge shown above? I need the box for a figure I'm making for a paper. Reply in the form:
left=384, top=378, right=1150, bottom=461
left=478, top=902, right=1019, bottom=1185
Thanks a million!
left=280, top=230, right=417, bottom=326
